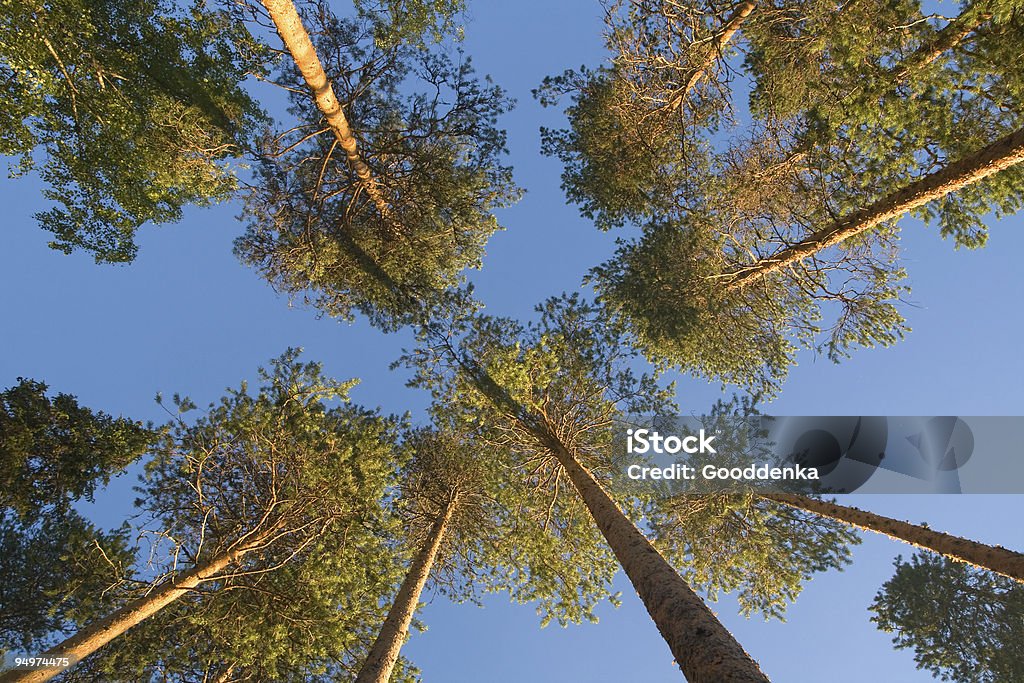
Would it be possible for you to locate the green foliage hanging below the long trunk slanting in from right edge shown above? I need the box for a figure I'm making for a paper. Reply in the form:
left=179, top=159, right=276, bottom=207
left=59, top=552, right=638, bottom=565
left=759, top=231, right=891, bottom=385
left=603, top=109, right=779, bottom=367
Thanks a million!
left=588, top=214, right=908, bottom=395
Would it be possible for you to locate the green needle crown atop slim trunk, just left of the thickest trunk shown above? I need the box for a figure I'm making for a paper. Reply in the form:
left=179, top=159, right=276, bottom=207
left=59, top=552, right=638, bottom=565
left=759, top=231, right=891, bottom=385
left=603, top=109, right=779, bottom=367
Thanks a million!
left=389, top=405, right=613, bottom=626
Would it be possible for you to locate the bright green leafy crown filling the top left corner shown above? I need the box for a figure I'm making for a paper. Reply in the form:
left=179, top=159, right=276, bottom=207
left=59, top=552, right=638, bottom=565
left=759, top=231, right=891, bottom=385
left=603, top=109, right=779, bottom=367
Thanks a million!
left=0, top=0, right=262, bottom=262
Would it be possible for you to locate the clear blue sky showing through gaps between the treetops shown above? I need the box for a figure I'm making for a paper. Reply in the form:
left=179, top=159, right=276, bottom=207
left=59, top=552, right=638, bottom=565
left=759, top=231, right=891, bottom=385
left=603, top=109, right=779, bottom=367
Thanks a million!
left=0, top=0, right=1024, bottom=682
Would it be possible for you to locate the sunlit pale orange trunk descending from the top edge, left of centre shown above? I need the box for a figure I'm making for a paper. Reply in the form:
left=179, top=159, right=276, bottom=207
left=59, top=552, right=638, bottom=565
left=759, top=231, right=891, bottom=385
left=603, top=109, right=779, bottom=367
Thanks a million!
left=262, top=0, right=392, bottom=223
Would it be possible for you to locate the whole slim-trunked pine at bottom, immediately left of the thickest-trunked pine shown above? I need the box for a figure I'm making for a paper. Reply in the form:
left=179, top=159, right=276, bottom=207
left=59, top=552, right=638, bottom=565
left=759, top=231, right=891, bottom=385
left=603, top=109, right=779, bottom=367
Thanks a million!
left=356, top=411, right=655, bottom=681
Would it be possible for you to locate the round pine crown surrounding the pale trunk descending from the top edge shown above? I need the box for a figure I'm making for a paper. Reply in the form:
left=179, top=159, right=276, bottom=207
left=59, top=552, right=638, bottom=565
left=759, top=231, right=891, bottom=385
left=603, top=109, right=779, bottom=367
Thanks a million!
left=236, top=4, right=519, bottom=329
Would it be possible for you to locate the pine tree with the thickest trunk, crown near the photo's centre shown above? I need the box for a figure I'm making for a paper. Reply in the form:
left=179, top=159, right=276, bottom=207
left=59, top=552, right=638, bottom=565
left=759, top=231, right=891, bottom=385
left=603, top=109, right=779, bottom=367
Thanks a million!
left=406, top=296, right=767, bottom=681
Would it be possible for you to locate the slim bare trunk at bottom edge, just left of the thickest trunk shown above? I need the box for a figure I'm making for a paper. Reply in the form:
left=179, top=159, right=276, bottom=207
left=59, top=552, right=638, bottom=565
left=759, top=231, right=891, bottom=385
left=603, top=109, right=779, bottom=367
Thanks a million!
left=355, top=501, right=456, bottom=683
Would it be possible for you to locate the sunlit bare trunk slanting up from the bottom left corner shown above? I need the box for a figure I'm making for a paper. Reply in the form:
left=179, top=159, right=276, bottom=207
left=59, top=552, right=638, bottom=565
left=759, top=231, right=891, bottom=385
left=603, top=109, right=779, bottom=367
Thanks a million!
left=0, top=539, right=262, bottom=683
